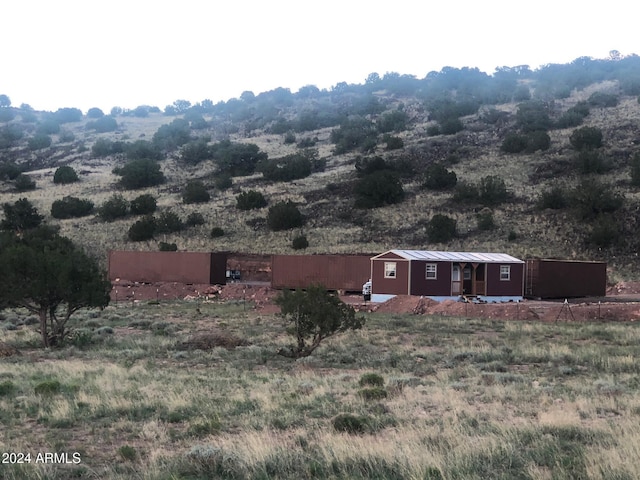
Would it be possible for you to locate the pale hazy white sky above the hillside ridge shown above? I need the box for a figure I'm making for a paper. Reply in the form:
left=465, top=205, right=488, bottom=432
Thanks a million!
left=0, top=0, right=640, bottom=112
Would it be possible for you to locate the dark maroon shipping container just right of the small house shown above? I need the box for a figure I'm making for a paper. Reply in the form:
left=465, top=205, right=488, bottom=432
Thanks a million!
left=525, top=259, right=607, bottom=298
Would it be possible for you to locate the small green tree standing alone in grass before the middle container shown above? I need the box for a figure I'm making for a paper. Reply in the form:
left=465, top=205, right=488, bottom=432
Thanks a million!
left=276, top=285, right=365, bottom=358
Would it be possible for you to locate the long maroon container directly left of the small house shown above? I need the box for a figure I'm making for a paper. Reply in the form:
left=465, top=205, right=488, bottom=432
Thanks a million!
left=271, top=255, right=371, bottom=292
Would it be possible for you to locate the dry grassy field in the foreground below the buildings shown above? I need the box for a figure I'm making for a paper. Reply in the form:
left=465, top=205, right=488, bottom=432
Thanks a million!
left=0, top=303, right=640, bottom=480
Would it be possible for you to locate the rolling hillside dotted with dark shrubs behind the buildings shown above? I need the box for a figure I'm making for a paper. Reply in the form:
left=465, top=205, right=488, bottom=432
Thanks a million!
left=0, top=57, right=640, bottom=280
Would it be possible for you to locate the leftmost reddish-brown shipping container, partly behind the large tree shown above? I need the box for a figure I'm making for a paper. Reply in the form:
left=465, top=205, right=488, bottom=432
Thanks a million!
left=109, top=251, right=226, bottom=284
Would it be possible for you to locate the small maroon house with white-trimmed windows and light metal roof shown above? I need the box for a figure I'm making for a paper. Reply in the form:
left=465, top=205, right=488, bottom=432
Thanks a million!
left=371, top=250, right=525, bottom=302
